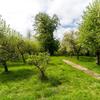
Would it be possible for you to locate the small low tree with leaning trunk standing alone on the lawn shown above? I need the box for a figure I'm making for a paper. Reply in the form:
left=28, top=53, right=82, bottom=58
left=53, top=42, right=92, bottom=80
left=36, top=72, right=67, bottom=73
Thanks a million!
left=27, top=53, right=50, bottom=80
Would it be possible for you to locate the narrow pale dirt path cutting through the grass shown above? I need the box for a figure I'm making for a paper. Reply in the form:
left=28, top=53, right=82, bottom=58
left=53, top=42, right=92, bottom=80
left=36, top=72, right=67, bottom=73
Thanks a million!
left=63, top=60, right=100, bottom=79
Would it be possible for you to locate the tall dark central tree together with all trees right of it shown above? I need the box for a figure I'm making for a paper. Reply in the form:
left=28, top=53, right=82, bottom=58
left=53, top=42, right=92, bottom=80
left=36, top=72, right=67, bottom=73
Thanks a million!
left=34, top=0, right=100, bottom=65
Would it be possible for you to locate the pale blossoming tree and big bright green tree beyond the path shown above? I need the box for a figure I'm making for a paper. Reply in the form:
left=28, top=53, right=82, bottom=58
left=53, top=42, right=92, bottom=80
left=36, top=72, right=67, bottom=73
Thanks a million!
left=61, top=0, right=100, bottom=65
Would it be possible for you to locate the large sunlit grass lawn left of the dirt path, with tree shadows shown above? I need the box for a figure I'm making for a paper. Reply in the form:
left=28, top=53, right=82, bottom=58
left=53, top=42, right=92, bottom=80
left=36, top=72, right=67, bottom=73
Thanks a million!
left=0, top=57, right=100, bottom=100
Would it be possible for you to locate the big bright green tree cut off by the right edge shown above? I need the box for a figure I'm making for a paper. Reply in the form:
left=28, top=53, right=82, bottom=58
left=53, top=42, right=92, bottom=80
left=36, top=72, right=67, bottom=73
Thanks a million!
left=79, top=0, right=100, bottom=64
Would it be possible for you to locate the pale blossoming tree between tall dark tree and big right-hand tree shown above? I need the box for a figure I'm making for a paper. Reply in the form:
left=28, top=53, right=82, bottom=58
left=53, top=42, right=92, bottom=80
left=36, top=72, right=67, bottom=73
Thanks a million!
left=61, top=31, right=82, bottom=59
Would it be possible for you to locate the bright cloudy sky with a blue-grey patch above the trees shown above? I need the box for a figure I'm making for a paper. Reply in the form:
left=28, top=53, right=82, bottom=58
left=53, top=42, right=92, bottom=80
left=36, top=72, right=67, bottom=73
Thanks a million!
left=0, top=0, right=92, bottom=38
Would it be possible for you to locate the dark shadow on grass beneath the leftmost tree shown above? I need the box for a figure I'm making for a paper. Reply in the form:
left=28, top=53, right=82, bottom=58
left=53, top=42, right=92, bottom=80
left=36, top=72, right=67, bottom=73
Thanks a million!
left=0, top=69, right=34, bottom=83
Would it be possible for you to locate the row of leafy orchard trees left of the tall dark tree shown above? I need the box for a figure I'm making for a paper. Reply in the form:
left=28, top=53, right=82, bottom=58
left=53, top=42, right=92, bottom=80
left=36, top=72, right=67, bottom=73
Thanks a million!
left=0, top=18, right=40, bottom=72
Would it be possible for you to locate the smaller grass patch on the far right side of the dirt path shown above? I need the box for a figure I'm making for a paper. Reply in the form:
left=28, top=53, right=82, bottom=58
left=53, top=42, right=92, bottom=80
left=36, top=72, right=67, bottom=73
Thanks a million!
left=66, top=56, right=100, bottom=73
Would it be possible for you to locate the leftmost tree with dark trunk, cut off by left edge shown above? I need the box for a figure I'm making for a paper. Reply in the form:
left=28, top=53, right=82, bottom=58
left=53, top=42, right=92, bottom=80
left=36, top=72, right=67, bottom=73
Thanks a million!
left=0, top=18, right=18, bottom=72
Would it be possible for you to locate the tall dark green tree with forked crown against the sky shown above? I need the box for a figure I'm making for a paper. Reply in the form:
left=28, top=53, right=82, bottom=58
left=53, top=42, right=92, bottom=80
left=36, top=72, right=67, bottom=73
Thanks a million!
left=34, top=13, right=59, bottom=55
